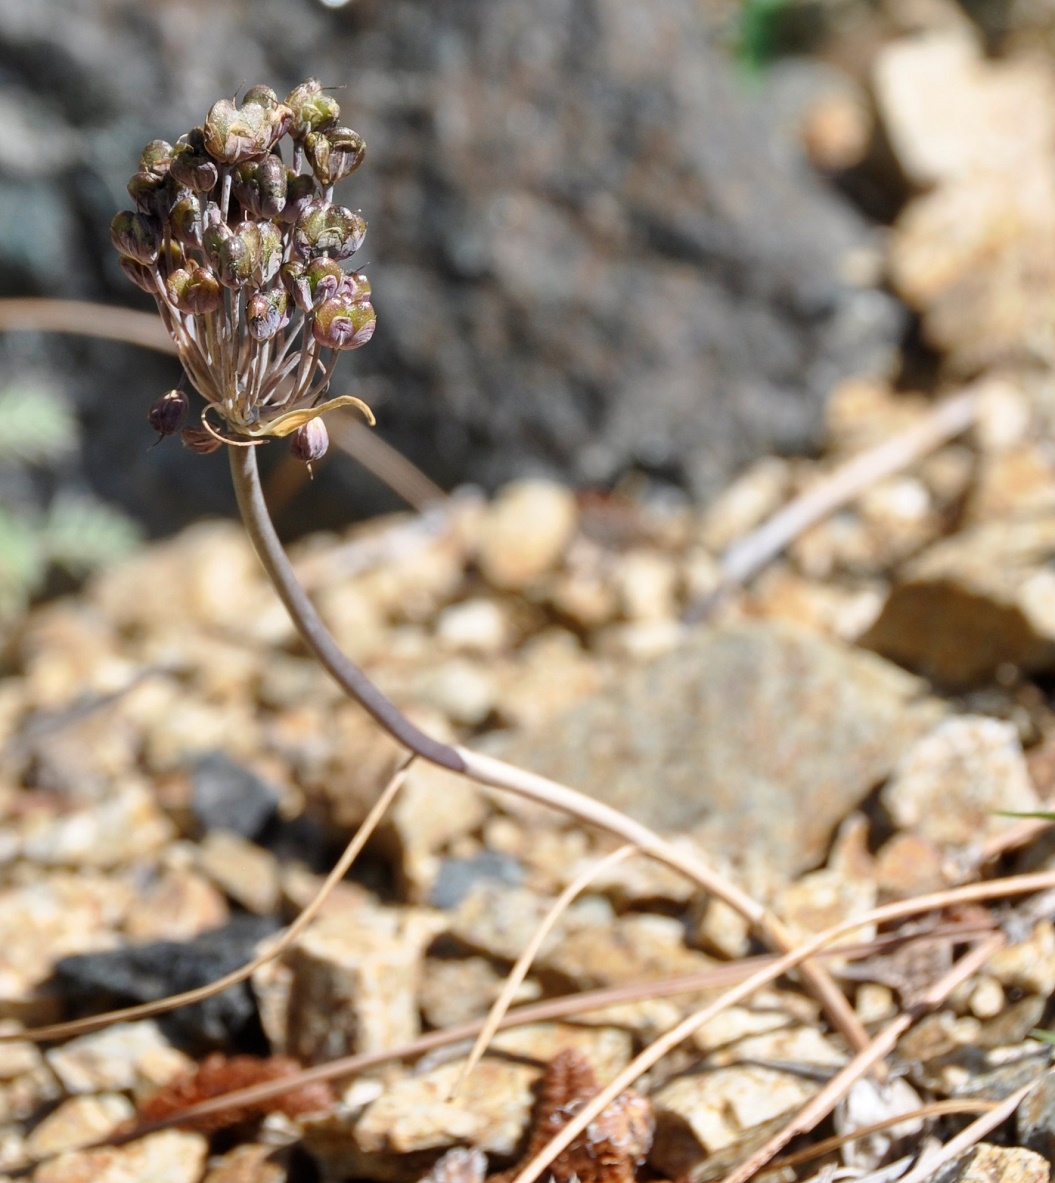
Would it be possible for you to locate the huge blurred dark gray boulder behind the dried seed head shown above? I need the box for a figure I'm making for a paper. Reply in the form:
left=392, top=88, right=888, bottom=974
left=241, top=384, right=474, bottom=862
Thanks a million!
left=0, top=0, right=900, bottom=529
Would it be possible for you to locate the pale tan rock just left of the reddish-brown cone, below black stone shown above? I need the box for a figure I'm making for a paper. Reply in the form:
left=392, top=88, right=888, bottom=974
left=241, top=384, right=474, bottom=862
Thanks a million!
left=45, top=1019, right=194, bottom=1093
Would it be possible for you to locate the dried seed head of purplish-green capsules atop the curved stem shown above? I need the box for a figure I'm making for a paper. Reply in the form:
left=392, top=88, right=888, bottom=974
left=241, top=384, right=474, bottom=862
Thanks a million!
left=110, top=78, right=375, bottom=463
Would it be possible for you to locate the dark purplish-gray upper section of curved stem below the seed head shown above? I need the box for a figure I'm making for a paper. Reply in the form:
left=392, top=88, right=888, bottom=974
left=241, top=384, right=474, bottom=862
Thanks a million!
left=227, top=447, right=465, bottom=772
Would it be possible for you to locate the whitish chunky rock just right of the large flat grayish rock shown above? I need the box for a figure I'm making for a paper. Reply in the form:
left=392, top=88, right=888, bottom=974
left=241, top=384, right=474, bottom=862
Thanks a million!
left=882, top=716, right=1040, bottom=846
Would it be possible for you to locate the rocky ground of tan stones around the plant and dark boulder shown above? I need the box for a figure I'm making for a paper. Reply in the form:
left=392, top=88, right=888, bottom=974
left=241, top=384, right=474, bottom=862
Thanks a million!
left=0, top=4, right=1055, bottom=1183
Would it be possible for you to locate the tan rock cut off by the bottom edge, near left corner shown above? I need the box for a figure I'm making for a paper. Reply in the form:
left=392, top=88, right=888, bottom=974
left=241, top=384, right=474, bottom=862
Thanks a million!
left=33, top=1130, right=208, bottom=1183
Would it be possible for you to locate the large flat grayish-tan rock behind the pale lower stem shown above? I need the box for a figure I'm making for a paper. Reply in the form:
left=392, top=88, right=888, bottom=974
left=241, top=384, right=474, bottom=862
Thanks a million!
left=480, top=623, right=943, bottom=879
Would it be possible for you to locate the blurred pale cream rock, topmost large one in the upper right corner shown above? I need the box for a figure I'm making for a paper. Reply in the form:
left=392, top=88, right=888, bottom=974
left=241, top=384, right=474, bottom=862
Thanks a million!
left=874, top=31, right=1055, bottom=186
